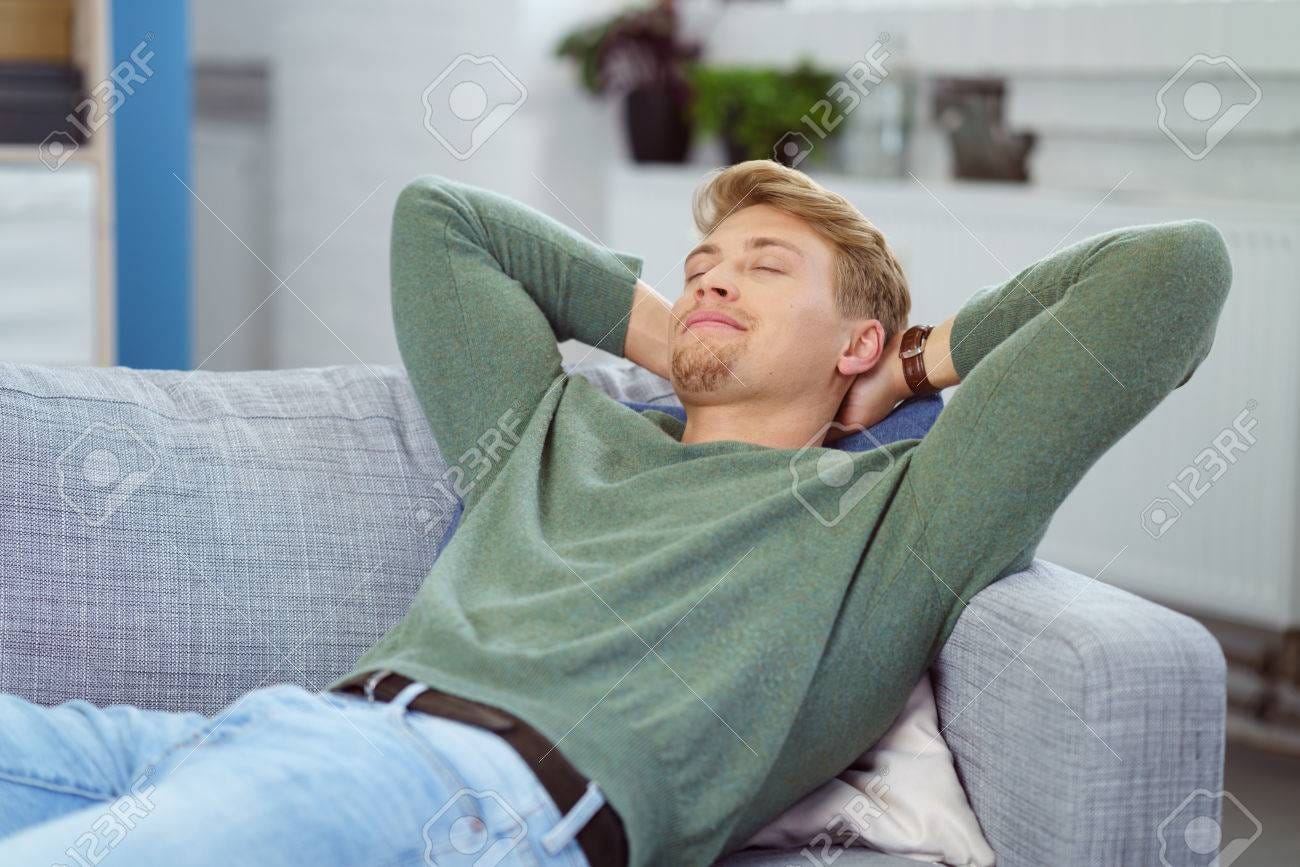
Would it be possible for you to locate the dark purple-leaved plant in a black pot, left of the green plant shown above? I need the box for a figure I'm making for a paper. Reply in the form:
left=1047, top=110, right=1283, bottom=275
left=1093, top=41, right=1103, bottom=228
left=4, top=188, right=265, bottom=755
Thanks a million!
left=555, top=0, right=699, bottom=162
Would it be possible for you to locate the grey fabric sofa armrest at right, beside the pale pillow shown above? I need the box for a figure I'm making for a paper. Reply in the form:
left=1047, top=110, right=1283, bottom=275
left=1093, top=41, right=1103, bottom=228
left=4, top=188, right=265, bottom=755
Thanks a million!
left=933, top=559, right=1225, bottom=867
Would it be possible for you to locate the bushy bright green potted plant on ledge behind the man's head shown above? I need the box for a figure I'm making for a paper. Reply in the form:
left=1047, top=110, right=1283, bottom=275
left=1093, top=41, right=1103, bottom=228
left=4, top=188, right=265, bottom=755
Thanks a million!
left=688, top=60, right=836, bottom=165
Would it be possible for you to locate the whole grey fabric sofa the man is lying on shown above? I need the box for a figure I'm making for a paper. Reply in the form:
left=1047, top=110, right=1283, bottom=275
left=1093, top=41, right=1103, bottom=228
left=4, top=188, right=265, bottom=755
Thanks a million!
left=0, top=361, right=1225, bottom=867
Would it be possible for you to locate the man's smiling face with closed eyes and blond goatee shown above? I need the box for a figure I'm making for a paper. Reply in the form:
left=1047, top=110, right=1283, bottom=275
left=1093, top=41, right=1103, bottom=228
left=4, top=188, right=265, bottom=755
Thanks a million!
left=672, top=204, right=853, bottom=403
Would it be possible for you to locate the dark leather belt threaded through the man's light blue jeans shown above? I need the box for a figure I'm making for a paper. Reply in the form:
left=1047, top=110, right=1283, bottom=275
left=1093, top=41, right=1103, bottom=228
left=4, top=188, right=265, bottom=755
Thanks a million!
left=327, top=672, right=628, bottom=867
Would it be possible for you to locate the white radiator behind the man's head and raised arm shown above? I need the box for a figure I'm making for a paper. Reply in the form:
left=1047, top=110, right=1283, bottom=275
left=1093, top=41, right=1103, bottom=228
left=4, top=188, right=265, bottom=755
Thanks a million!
left=602, top=162, right=1300, bottom=628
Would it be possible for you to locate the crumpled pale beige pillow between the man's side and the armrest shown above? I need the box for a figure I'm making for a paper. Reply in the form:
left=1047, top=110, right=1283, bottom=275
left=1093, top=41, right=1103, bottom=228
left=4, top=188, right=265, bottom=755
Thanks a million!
left=745, top=673, right=993, bottom=867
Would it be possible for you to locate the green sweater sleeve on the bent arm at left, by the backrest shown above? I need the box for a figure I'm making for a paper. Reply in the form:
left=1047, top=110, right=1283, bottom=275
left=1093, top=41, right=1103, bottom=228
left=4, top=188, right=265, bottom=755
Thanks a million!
left=390, top=175, right=642, bottom=511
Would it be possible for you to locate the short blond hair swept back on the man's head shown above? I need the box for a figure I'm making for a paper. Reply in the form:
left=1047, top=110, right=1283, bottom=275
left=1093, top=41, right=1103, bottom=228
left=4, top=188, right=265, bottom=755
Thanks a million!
left=692, top=160, right=911, bottom=339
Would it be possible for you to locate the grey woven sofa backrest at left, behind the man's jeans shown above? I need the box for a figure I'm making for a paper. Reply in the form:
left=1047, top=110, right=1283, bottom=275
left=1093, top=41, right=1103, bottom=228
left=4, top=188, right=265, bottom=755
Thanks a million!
left=0, top=364, right=483, bottom=712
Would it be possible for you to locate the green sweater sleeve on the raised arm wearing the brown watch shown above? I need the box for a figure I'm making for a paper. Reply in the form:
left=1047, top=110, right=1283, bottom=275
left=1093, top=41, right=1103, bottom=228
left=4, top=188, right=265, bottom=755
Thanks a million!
left=874, top=220, right=1232, bottom=653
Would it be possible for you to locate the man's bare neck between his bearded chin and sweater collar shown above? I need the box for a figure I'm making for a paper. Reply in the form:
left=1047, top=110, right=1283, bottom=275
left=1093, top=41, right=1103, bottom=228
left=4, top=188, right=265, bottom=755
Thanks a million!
left=681, top=395, right=839, bottom=448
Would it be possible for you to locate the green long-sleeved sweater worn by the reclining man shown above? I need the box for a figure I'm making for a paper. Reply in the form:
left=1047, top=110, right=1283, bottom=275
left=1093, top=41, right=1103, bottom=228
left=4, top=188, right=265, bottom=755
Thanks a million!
left=337, top=175, right=1231, bottom=867
